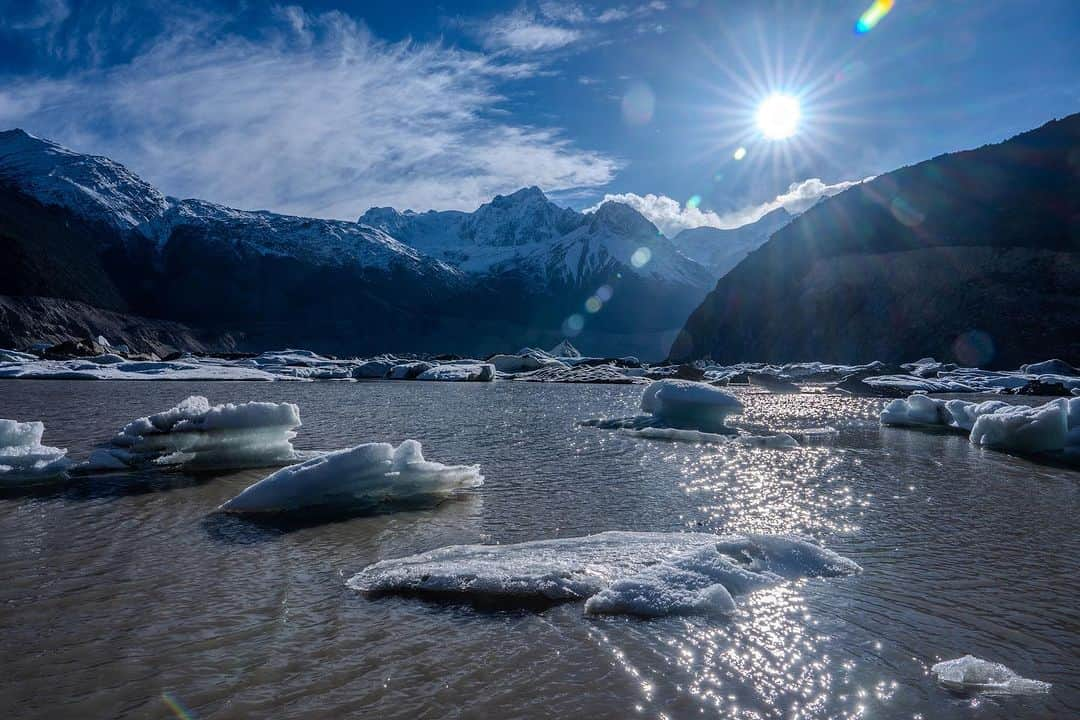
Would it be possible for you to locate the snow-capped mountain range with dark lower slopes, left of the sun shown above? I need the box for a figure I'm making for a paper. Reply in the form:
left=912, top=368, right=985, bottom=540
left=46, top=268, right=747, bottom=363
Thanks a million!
left=0, top=131, right=713, bottom=357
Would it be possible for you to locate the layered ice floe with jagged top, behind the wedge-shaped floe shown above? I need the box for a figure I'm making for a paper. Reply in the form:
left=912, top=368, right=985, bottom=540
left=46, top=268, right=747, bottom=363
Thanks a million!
left=82, top=395, right=300, bottom=471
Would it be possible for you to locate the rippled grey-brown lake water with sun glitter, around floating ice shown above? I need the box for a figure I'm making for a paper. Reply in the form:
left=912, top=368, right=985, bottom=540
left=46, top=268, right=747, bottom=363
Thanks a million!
left=0, top=381, right=1080, bottom=720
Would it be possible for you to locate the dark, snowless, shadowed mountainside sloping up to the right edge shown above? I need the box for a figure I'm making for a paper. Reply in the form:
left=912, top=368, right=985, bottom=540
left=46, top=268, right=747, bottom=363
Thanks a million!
left=670, top=114, right=1080, bottom=367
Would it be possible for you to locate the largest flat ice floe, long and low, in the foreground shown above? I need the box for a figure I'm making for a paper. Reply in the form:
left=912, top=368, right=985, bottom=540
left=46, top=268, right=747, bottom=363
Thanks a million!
left=348, top=532, right=860, bottom=617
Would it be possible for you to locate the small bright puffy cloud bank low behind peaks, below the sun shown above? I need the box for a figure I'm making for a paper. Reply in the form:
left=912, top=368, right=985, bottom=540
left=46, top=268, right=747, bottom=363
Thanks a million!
left=584, top=177, right=873, bottom=237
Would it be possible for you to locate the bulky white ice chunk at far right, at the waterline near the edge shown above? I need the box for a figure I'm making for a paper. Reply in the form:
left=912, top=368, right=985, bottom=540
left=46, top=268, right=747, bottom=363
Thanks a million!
left=971, top=398, right=1070, bottom=452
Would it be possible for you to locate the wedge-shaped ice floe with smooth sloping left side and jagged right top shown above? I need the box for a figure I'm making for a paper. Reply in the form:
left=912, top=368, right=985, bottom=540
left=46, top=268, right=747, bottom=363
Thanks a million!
left=220, top=440, right=484, bottom=513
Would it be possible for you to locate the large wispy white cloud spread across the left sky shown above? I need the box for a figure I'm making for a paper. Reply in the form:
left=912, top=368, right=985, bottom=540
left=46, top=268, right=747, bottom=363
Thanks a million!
left=0, top=9, right=619, bottom=218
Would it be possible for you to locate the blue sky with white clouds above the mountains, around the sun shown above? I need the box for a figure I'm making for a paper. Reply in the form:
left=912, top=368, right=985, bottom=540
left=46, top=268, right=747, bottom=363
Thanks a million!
left=0, top=0, right=1080, bottom=232
